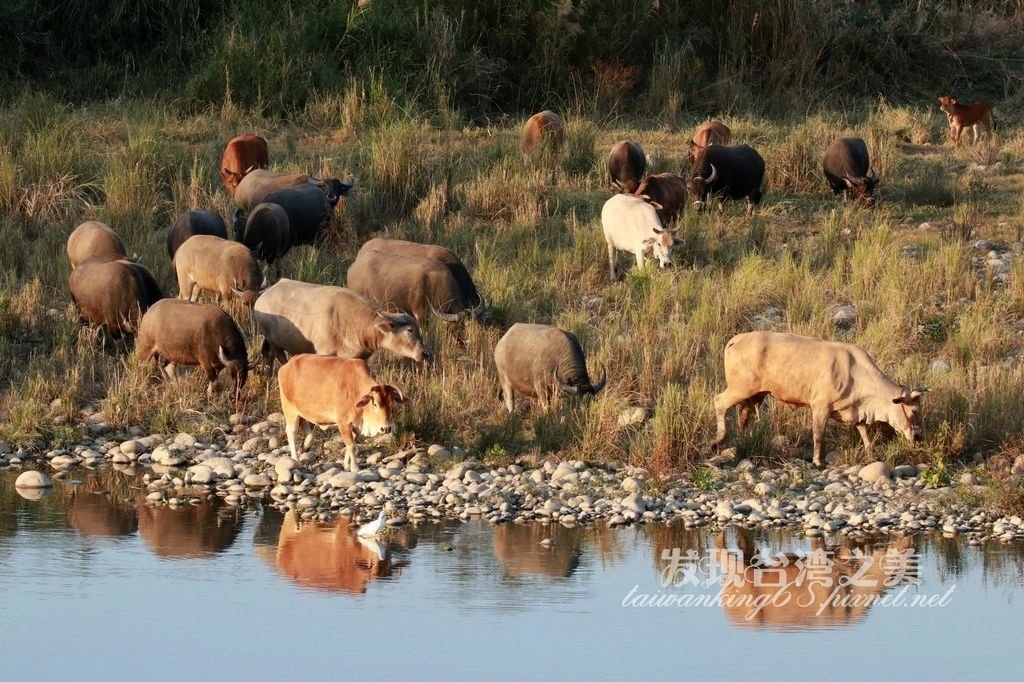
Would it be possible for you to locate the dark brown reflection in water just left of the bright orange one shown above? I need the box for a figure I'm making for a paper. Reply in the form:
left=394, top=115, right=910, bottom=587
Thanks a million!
left=137, top=500, right=241, bottom=558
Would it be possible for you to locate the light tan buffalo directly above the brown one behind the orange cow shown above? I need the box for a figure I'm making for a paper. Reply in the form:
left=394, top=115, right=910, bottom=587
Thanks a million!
left=174, top=235, right=263, bottom=305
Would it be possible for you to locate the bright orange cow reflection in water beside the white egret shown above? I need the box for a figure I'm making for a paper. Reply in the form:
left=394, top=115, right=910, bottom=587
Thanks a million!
left=254, top=510, right=415, bottom=594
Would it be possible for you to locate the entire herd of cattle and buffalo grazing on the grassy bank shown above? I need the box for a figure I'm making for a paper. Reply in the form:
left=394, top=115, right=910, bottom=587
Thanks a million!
left=68, top=97, right=992, bottom=470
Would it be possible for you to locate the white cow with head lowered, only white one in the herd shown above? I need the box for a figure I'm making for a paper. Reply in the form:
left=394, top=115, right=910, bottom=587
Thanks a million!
left=601, top=195, right=679, bottom=282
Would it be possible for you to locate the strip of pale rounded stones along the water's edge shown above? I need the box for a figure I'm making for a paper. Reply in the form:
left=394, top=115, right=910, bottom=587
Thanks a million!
left=0, top=414, right=1024, bottom=544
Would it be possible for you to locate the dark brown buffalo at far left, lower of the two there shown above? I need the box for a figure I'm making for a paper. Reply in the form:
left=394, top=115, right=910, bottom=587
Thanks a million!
left=68, top=258, right=159, bottom=339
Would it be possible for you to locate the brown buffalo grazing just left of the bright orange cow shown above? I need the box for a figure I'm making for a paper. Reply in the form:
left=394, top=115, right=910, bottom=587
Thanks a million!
left=138, top=298, right=249, bottom=401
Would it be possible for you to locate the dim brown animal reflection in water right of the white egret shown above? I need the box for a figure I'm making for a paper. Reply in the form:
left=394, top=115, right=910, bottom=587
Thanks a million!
left=494, top=523, right=582, bottom=579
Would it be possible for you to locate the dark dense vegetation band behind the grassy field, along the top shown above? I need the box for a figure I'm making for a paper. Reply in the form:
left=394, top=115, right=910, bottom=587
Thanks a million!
left=6, top=0, right=1024, bottom=119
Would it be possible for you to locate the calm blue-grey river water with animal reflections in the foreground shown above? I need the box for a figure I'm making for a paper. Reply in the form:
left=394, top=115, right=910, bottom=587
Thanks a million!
left=0, top=470, right=1024, bottom=682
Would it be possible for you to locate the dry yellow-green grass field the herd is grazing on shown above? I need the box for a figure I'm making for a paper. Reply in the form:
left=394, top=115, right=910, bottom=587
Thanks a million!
left=0, top=94, right=1024, bottom=473
